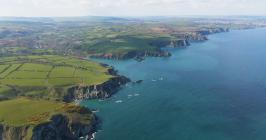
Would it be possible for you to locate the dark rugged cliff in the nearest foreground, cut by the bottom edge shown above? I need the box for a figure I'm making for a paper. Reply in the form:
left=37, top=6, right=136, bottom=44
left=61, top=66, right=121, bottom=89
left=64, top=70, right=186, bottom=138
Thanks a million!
left=32, top=115, right=96, bottom=140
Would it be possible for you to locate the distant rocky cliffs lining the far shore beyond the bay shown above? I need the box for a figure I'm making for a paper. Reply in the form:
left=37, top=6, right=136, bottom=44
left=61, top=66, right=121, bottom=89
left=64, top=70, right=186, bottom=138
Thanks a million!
left=90, top=28, right=229, bottom=60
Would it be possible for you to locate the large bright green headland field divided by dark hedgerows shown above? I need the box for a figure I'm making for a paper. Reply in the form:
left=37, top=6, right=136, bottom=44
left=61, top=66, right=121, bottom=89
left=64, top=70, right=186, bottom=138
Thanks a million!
left=0, top=55, right=113, bottom=99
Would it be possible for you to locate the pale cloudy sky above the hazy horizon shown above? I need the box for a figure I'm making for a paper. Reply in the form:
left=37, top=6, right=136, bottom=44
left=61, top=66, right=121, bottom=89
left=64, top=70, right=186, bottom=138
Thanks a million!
left=0, top=0, right=266, bottom=17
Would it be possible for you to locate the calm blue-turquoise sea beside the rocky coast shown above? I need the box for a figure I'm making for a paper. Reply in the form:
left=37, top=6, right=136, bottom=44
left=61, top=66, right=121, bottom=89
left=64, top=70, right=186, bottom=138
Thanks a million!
left=83, top=29, right=266, bottom=140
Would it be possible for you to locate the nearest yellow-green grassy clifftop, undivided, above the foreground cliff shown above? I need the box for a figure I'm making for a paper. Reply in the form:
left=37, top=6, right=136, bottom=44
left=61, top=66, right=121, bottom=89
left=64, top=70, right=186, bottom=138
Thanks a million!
left=0, top=98, right=65, bottom=126
